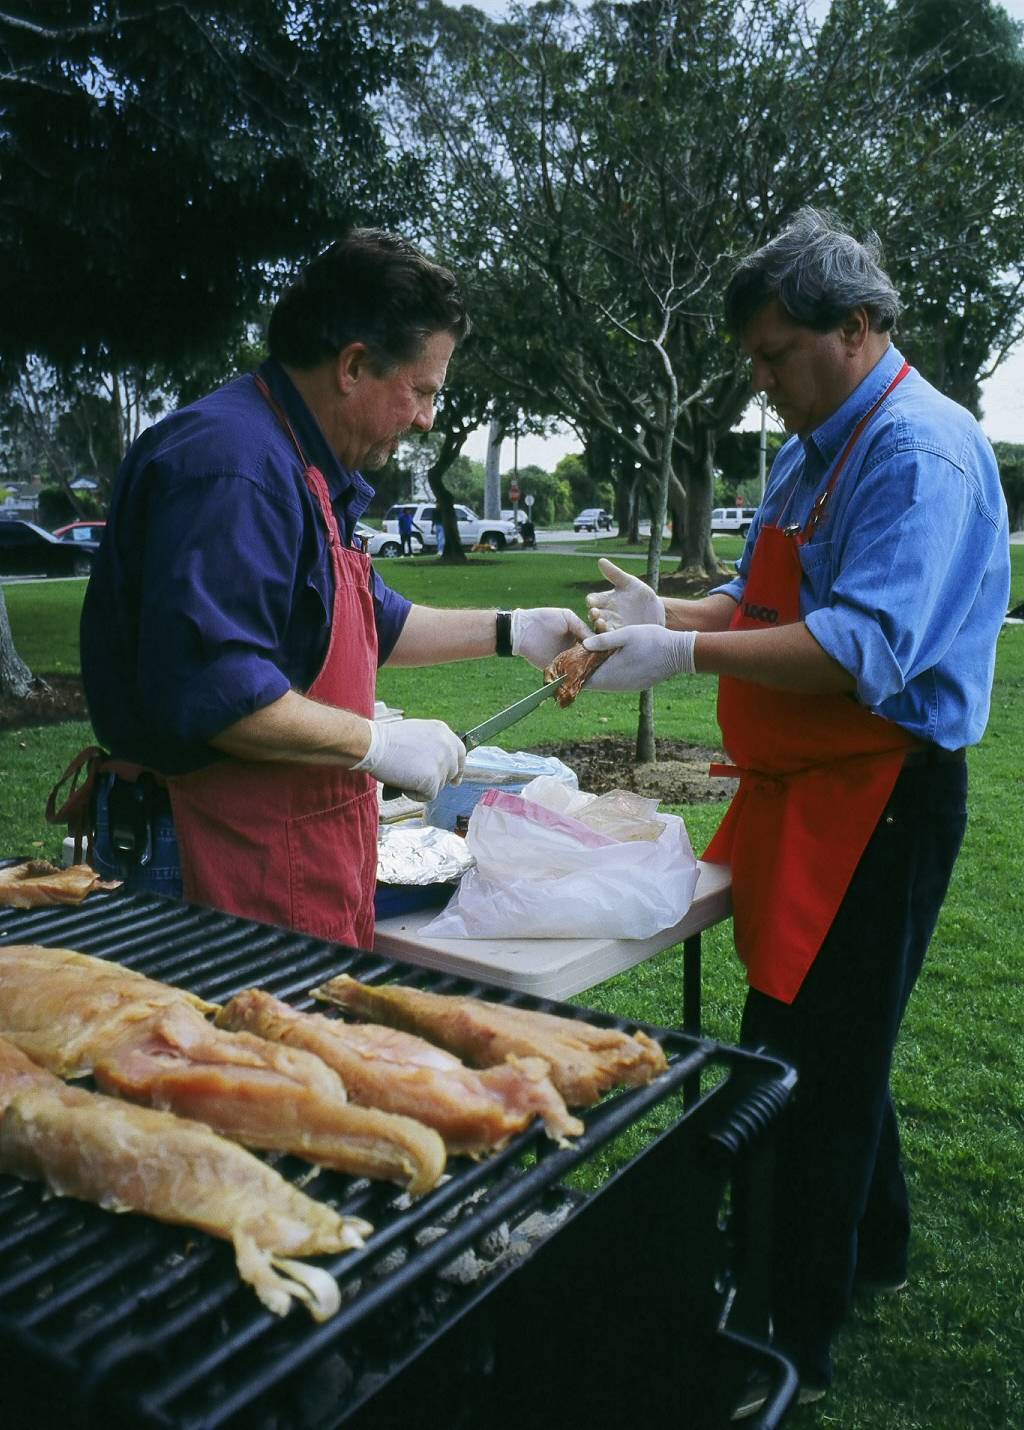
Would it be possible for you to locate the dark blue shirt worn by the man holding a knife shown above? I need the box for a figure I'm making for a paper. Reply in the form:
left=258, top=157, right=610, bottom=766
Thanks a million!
left=82, top=362, right=409, bottom=774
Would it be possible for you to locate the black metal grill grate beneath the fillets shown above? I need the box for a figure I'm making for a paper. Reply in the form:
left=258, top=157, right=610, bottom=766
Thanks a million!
left=0, top=895, right=789, bottom=1430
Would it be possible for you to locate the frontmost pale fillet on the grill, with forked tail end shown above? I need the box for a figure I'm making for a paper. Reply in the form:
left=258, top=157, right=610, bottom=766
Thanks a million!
left=0, top=1038, right=373, bottom=1321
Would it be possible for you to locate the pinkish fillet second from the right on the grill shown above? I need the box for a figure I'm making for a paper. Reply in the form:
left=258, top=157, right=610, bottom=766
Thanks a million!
left=217, top=988, right=584, bottom=1155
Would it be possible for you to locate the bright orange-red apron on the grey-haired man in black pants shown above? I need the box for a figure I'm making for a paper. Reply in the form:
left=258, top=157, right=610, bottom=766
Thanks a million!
left=704, top=363, right=918, bottom=1002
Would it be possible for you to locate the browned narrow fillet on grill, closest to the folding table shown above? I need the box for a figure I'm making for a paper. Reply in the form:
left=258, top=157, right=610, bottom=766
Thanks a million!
left=313, top=974, right=668, bottom=1107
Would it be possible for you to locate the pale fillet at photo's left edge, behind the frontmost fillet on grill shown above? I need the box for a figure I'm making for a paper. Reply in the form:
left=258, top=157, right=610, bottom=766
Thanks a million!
left=0, top=944, right=216, bottom=1077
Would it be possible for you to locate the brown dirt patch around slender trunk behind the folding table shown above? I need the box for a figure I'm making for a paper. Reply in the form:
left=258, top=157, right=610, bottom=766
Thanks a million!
left=533, top=735, right=737, bottom=804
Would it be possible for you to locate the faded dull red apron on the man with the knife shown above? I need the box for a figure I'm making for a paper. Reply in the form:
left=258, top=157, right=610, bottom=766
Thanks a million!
left=167, top=376, right=379, bottom=948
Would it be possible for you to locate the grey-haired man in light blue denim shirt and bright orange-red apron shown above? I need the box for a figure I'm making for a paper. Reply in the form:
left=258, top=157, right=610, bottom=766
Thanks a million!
left=586, top=210, right=1010, bottom=1413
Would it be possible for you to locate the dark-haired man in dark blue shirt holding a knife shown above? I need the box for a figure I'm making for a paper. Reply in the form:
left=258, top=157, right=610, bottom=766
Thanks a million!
left=82, top=229, right=586, bottom=947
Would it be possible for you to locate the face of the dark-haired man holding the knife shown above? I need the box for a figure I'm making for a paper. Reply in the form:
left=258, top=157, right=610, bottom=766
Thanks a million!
left=338, top=333, right=455, bottom=472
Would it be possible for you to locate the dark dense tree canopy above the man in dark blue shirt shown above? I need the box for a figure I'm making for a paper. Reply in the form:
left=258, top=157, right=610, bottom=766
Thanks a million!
left=0, top=0, right=413, bottom=380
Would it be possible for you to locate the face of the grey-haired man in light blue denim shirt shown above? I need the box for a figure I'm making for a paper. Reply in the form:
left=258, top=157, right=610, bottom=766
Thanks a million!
left=741, top=299, right=860, bottom=436
